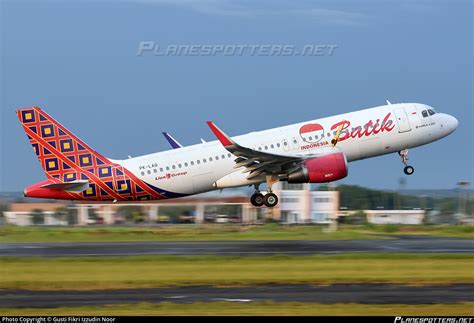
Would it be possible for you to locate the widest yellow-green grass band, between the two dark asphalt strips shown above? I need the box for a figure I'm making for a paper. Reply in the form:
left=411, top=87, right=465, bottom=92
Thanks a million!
left=0, top=254, right=474, bottom=290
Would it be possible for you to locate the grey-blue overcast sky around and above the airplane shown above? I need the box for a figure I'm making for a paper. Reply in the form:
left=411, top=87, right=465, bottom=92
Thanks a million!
left=0, top=0, right=474, bottom=191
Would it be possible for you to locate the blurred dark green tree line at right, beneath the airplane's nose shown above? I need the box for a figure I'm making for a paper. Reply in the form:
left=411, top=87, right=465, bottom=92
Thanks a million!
left=317, top=185, right=474, bottom=214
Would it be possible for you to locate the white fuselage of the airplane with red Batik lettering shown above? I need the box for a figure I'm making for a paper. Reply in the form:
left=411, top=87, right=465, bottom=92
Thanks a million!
left=115, top=103, right=458, bottom=195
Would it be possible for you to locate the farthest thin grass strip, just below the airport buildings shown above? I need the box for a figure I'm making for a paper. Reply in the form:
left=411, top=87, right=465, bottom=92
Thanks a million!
left=0, top=224, right=474, bottom=242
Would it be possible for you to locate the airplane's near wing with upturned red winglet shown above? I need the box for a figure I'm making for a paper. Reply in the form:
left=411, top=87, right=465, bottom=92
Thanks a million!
left=207, top=121, right=338, bottom=179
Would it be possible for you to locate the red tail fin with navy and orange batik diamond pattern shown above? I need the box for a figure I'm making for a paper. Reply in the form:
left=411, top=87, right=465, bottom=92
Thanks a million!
left=17, top=107, right=170, bottom=201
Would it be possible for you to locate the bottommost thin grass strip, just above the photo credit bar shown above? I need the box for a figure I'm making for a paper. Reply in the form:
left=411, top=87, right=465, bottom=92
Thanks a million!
left=0, top=302, right=474, bottom=316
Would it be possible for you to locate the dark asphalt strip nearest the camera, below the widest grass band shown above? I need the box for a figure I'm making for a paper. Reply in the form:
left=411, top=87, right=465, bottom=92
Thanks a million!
left=0, top=284, right=474, bottom=308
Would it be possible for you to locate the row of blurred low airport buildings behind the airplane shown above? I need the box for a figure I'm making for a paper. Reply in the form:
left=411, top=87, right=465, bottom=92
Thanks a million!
left=4, top=182, right=425, bottom=225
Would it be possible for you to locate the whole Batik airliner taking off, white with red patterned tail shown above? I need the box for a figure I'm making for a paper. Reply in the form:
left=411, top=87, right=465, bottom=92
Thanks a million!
left=17, top=102, right=458, bottom=207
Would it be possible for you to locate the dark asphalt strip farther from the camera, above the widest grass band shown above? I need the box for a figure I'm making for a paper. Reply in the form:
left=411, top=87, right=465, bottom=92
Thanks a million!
left=0, top=235, right=474, bottom=257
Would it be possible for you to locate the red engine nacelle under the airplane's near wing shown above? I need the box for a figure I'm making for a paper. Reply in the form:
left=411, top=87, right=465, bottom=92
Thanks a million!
left=287, top=153, right=347, bottom=183
